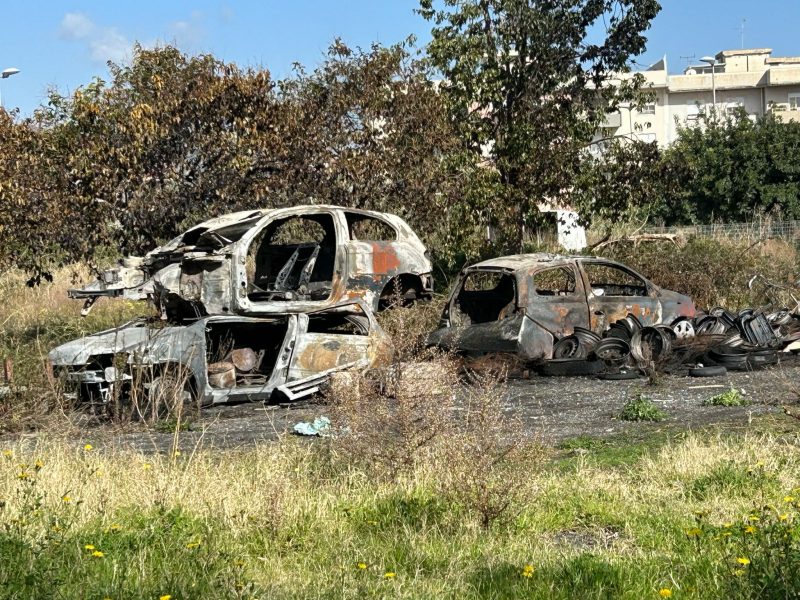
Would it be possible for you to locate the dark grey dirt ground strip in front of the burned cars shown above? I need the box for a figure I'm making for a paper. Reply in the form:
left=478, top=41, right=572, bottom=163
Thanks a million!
left=47, top=357, right=800, bottom=451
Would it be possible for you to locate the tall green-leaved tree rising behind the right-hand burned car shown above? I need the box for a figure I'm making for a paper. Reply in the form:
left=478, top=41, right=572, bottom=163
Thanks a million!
left=420, top=0, right=660, bottom=250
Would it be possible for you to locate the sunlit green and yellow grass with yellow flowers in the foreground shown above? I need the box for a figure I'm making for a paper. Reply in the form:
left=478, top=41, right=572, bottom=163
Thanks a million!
left=0, top=433, right=800, bottom=600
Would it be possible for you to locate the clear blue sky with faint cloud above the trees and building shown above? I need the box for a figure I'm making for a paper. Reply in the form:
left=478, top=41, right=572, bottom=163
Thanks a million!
left=0, top=0, right=800, bottom=115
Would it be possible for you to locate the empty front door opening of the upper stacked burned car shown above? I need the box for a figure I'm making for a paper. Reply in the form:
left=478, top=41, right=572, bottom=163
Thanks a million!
left=246, top=214, right=336, bottom=301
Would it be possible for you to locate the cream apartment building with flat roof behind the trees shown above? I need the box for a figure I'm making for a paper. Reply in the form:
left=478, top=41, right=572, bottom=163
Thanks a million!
left=598, top=48, right=800, bottom=146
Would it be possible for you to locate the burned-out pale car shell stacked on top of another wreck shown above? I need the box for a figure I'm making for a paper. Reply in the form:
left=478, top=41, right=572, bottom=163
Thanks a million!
left=69, top=205, right=433, bottom=322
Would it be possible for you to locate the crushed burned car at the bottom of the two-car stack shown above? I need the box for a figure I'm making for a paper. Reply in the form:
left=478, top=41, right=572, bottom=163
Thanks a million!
left=49, top=300, right=392, bottom=407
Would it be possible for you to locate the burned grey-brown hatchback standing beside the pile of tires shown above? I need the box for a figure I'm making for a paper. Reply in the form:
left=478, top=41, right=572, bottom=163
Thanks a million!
left=428, top=254, right=695, bottom=361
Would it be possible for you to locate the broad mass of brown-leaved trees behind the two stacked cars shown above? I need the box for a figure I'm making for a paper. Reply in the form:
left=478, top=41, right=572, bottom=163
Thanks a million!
left=0, top=42, right=470, bottom=273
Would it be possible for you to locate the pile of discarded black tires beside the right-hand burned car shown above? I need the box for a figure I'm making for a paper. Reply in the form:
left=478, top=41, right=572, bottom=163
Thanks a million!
left=538, top=307, right=800, bottom=380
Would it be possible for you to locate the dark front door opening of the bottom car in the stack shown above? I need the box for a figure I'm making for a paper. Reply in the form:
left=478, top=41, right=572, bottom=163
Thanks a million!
left=206, top=320, right=287, bottom=389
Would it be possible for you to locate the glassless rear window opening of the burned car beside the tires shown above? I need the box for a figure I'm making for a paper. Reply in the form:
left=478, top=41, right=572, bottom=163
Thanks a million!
left=454, top=271, right=517, bottom=325
